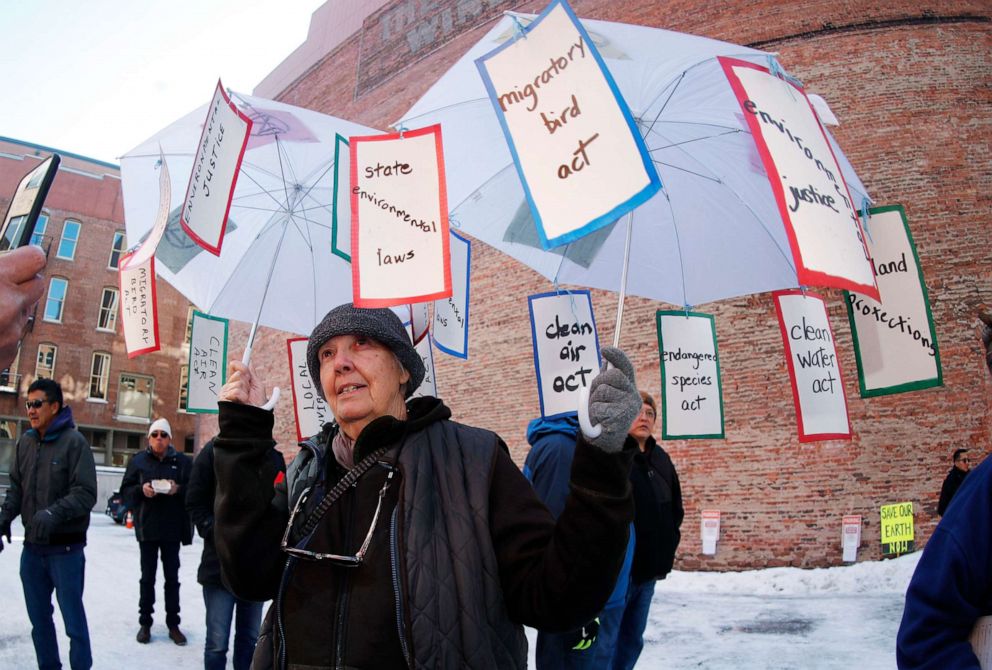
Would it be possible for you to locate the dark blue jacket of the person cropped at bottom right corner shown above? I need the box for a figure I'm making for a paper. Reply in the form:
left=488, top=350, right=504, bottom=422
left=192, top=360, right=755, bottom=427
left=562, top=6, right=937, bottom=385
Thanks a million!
left=896, top=458, right=992, bottom=670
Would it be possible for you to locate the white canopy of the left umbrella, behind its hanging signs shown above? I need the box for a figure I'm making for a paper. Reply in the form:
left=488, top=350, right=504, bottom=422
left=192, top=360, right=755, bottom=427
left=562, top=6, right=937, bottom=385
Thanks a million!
left=121, top=93, right=380, bottom=335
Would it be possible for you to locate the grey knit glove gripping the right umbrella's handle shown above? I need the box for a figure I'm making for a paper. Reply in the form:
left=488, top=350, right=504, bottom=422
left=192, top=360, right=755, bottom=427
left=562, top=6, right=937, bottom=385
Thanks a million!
left=586, top=347, right=641, bottom=453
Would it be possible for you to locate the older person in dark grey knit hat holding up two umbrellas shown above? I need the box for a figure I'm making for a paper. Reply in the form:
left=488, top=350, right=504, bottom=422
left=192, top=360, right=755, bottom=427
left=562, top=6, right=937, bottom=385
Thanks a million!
left=214, top=304, right=641, bottom=670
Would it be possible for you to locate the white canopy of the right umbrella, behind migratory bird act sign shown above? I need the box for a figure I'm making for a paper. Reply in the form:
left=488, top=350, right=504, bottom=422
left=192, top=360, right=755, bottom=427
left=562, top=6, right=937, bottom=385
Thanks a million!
left=397, top=14, right=867, bottom=305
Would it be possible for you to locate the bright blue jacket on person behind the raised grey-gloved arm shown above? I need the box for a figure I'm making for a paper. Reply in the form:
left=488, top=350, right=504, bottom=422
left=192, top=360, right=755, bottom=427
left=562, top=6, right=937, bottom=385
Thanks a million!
left=524, top=415, right=634, bottom=609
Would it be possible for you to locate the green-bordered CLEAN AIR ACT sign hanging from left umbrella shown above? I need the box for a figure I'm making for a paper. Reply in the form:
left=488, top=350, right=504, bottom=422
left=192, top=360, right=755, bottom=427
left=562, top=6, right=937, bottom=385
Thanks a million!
left=186, top=310, right=227, bottom=414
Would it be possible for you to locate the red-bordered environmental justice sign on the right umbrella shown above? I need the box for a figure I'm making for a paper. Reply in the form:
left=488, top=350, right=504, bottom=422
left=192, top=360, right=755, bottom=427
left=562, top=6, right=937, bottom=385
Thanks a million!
left=720, top=58, right=878, bottom=297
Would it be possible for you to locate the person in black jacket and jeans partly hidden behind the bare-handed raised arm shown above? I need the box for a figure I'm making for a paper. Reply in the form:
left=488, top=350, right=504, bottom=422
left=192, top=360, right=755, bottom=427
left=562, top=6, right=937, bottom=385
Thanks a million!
left=186, top=440, right=286, bottom=670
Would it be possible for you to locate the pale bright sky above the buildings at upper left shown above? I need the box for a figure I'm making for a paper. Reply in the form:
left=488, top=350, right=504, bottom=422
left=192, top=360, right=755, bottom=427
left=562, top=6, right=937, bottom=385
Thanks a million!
left=0, top=0, right=324, bottom=163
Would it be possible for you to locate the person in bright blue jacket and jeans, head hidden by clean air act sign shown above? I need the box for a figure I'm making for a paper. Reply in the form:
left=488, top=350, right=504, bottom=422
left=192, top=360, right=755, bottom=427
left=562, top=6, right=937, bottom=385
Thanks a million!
left=524, top=415, right=634, bottom=670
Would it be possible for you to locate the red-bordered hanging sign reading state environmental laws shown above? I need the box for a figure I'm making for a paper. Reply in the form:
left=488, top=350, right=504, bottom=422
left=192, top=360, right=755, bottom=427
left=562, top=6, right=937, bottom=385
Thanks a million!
left=349, top=125, right=451, bottom=307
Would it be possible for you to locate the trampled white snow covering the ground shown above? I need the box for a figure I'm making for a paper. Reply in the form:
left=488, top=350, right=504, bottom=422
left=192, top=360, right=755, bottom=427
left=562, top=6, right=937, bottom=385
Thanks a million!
left=0, top=514, right=919, bottom=670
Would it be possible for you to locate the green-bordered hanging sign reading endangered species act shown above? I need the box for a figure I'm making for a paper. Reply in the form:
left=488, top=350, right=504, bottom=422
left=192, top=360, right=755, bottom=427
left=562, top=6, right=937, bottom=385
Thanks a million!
left=657, top=311, right=723, bottom=440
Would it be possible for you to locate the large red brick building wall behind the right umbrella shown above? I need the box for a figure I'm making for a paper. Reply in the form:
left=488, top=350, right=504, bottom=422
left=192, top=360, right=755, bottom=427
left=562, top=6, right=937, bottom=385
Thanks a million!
left=196, top=0, right=992, bottom=570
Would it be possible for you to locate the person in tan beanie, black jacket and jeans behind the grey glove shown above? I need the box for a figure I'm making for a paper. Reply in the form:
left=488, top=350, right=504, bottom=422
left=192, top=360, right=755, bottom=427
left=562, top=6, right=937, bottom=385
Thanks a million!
left=612, top=391, right=685, bottom=670
